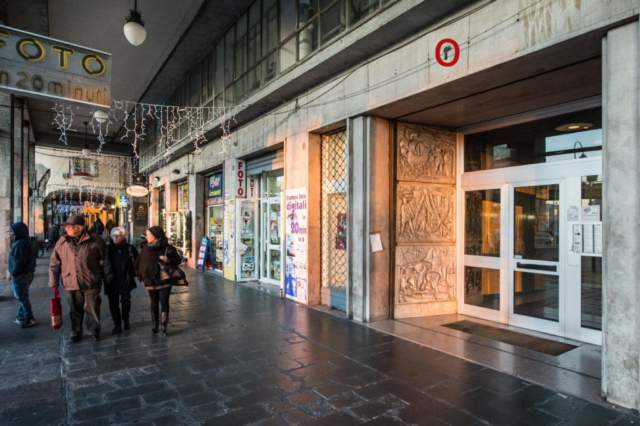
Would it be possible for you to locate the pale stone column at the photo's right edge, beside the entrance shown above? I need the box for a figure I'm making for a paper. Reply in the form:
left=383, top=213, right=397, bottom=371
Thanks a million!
left=602, top=21, right=640, bottom=409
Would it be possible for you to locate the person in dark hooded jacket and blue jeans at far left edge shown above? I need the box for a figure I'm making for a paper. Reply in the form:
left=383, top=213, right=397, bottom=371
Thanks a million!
left=8, top=222, right=36, bottom=328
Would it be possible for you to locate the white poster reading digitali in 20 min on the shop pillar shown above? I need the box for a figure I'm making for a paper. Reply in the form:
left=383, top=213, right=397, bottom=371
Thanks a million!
left=284, top=188, right=307, bottom=303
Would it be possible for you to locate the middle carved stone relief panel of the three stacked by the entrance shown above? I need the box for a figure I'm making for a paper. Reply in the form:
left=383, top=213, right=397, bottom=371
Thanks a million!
left=396, top=183, right=455, bottom=243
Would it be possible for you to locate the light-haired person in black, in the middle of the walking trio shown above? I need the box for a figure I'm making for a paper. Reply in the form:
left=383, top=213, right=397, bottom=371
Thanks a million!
left=104, top=225, right=138, bottom=334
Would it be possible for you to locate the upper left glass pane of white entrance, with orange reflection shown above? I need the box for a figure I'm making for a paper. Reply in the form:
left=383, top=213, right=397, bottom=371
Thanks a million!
left=464, top=189, right=500, bottom=257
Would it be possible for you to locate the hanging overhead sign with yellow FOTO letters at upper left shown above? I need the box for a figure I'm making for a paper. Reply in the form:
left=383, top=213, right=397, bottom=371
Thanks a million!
left=0, top=25, right=111, bottom=107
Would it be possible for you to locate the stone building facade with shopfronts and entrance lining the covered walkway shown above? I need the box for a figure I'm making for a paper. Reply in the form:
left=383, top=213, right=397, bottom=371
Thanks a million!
left=141, top=0, right=640, bottom=409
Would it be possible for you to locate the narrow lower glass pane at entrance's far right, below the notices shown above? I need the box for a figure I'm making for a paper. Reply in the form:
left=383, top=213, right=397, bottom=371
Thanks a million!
left=581, top=256, right=602, bottom=330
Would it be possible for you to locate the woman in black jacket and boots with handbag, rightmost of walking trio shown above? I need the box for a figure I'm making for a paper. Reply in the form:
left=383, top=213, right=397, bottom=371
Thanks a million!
left=136, top=226, right=182, bottom=336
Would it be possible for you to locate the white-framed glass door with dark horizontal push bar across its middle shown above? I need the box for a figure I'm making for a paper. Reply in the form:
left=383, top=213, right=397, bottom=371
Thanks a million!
left=509, top=180, right=566, bottom=335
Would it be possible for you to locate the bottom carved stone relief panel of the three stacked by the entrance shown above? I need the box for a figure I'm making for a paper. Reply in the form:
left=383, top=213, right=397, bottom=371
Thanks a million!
left=396, top=246, right=456, bottom=303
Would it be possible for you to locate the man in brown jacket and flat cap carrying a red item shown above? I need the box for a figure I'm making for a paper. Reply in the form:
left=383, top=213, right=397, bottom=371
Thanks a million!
left=49, top=214, right=113, bottom=342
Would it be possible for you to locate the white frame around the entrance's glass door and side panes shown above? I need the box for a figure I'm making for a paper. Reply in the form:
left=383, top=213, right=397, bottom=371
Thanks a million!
left=458, top=157, right=602, bottom=345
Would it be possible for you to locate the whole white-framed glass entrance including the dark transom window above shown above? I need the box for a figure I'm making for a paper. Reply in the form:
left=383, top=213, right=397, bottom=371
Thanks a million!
left=459, top=108, right=602, bottom=344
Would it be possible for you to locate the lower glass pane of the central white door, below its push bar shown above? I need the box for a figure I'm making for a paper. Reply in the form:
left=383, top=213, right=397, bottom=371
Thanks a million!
left=513, top=271, right=560, bottom=322
